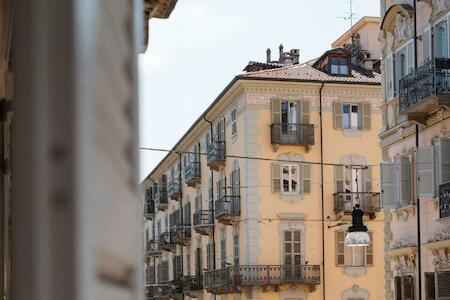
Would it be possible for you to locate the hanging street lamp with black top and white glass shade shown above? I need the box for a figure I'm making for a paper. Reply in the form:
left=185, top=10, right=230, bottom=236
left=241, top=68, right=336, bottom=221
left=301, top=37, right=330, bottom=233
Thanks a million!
left=344, top=203, right=370, bottom=247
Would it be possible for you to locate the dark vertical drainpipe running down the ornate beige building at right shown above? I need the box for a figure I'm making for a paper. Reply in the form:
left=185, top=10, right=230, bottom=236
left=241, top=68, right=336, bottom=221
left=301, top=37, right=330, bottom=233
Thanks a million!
left=413, top=0, right=424, bottom=300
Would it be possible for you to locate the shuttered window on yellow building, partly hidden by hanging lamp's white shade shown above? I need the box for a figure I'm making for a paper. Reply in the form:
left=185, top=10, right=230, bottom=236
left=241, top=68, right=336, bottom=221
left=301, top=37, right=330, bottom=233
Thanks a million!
left=336, top=230, right=373, bottom=267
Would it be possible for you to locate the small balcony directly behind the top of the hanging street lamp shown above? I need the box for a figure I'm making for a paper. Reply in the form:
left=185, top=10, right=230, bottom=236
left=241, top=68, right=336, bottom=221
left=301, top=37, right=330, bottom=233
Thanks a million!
left=333, top=192, right=380, bottom=219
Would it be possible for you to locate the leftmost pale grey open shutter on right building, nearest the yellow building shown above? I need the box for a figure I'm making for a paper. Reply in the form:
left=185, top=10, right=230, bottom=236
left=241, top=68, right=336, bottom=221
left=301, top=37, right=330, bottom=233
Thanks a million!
left=380, top=162, right=397, bottom=208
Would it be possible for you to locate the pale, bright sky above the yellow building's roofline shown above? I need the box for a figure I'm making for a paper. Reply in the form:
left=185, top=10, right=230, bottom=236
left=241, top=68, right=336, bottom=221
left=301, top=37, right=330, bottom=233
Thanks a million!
left=138, top=0, right=380, bottom=179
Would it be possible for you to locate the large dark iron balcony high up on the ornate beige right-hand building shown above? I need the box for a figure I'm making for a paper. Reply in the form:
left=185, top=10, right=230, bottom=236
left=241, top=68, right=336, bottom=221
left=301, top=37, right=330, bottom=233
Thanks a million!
left=399, top=58, right=450, bottom=124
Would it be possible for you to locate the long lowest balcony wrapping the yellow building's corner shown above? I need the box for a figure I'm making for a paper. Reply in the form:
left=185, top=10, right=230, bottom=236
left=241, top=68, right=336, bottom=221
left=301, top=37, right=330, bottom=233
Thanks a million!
left=204, top=265, right=320, bottom=295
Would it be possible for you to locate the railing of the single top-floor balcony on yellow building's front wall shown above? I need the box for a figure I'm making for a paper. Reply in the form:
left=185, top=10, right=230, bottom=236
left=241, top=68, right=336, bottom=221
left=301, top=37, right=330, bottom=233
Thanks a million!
left=270, top=123, right=314, bottom=146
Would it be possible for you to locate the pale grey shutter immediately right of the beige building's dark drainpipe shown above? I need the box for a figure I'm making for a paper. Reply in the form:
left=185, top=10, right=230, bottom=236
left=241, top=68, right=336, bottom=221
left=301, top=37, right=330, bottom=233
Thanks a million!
left=416, top=146, right=434, bottom=198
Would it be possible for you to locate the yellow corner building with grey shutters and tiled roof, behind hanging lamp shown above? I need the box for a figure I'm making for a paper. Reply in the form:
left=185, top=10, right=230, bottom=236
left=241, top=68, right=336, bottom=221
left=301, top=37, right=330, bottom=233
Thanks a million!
left=142, top=18, right=385, bottom=300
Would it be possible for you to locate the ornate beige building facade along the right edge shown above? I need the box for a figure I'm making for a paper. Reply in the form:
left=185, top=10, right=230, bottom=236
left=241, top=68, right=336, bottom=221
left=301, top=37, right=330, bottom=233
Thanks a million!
left=379, top=0, right=450, bottom=299
